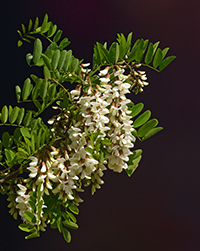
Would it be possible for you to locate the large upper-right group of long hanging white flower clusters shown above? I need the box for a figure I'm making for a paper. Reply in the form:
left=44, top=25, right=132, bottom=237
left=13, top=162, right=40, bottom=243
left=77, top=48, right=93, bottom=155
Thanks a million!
left=69, top=68, right=135, bottom=175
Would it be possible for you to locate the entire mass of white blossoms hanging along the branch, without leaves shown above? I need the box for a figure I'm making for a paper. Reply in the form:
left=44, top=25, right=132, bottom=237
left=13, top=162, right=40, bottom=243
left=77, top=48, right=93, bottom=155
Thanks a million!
left=11, top=67, right=142, bottom=227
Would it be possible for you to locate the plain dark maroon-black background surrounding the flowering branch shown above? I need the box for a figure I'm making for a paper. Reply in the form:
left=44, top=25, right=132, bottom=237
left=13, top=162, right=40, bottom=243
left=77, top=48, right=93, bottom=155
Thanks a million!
left=0, top=0, right=200, bottom=251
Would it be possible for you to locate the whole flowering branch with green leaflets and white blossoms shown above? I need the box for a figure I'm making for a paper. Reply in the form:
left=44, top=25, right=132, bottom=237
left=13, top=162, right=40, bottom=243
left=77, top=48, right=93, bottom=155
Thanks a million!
left=0, top=14, right=175, bottom=242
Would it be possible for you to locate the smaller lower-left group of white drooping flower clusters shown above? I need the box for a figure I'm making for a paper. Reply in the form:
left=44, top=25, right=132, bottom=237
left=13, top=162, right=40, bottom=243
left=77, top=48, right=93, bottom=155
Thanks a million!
left=12, top=152, right=78, bottom=226
